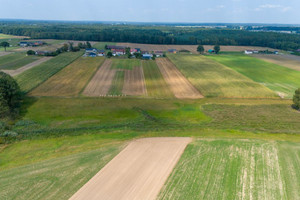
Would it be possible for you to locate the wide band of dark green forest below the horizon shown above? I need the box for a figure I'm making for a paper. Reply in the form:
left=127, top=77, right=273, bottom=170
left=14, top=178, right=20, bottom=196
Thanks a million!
left=0, top=21, right=300, bottom=50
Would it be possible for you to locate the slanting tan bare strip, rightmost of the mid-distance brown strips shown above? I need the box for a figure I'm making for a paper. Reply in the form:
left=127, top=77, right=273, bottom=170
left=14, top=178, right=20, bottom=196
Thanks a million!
left=156, top=58, right=203, bottom=99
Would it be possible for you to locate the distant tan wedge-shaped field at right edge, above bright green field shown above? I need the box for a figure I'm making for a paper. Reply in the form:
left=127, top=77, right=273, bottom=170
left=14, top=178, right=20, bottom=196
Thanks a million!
left=252, top=54, right=300, bottom=71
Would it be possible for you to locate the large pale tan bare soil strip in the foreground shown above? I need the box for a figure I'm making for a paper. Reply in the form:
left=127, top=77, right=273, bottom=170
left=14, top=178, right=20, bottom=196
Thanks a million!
left=70, top=138, right=191, bottom=200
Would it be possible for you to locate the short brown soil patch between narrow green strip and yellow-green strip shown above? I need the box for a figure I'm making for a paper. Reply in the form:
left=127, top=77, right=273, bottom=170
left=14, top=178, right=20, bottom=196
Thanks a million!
left=122, top=67, right=147, bottom=96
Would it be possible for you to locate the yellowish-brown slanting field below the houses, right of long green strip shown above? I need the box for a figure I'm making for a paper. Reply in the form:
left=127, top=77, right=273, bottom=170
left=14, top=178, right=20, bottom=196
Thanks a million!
left=29, top=57, right=104, bottom=97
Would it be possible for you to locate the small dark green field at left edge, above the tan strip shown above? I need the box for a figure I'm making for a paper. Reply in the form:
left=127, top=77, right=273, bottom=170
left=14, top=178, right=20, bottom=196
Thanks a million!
left=0, top=53, right=40, bottom=70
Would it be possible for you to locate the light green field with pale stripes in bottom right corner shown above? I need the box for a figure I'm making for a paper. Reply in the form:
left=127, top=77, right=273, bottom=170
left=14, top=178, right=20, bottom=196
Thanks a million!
left=159, top=140, right=300, bottom=200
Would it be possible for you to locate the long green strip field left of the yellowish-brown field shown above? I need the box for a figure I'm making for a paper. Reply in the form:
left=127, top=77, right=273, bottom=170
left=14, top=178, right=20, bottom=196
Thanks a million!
left=16, top=52, right=82, bottom=92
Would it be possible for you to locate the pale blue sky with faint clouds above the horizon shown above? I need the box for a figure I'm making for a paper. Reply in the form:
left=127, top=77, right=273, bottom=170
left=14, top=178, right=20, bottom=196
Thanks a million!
left=0, top=0, right=300, bottom=24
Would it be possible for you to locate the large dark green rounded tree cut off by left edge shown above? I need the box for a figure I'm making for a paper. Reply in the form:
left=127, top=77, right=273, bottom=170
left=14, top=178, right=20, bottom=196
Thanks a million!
left=0, top=72, right=22, bottom=118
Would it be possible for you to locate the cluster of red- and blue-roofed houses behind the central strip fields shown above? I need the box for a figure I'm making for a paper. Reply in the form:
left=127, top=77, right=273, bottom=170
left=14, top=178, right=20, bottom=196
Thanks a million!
left=84, top=45, right=177, bottom=59
